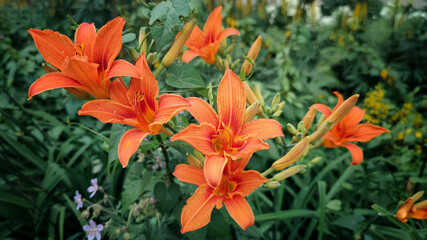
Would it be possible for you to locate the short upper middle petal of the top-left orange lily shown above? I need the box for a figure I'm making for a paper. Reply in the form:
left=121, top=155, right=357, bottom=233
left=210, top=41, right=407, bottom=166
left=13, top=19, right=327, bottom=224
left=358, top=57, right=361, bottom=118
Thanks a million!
left=74, top=23, right=96, bottom=59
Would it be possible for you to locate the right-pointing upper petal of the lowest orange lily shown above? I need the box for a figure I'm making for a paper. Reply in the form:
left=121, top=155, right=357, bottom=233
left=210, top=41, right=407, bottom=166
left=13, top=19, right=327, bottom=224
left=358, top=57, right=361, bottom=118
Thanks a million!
left=233, top=170, right=268, bottom=196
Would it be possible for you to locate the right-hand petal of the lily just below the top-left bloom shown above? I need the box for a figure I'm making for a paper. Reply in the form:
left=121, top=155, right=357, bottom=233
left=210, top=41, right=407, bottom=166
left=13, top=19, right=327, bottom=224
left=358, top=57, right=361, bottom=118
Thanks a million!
left=148, top=94, right=191, bottom=132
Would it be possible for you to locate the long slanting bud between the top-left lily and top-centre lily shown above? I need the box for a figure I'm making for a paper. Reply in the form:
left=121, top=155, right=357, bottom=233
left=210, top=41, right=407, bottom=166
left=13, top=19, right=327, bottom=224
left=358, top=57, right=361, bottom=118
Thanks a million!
left=161, top=19, right=196, bottom=67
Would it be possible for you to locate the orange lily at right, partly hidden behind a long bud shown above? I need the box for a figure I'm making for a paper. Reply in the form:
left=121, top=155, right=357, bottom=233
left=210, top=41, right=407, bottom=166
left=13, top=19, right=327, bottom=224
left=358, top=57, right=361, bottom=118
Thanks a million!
left=313, top=92, right=390, bottom=165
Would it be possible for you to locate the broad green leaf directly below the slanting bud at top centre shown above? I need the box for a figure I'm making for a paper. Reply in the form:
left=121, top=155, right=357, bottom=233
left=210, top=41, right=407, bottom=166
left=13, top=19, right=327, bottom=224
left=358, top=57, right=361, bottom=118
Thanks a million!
left=166, top=62, right=206, bottom=88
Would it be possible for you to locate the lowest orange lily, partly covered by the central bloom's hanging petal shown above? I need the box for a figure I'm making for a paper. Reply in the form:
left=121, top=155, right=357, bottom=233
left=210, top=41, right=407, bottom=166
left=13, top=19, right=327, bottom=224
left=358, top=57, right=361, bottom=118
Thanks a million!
left=173, top=158, right=268, bottom=234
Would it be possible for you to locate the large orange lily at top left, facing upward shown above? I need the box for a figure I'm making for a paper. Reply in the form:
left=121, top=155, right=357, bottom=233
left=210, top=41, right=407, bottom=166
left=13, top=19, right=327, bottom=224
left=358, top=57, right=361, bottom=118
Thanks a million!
left=28, top=17, right=140, bottom=99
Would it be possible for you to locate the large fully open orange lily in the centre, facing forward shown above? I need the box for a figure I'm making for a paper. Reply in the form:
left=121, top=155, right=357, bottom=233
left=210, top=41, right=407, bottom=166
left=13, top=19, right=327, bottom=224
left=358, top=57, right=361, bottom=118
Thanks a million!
left=171, top=70, right=283, bottom=187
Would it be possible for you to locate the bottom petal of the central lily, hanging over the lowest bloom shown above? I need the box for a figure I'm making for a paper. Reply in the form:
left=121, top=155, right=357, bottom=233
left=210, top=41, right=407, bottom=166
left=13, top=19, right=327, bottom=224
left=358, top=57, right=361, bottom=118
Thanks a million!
left=203, top=155, right=227, bottom=188
